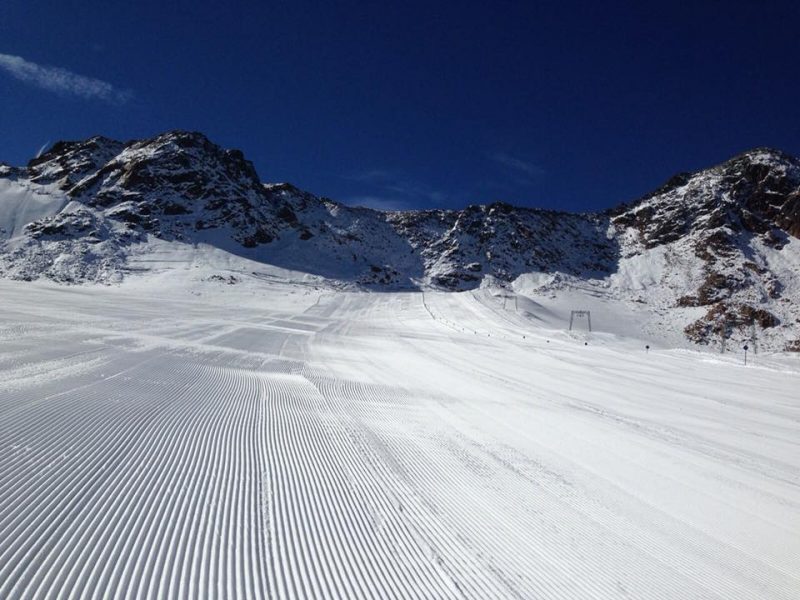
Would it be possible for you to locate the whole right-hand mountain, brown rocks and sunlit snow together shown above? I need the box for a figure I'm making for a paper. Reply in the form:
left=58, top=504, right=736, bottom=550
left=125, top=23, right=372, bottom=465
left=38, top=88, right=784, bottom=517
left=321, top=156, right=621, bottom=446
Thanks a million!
left=611, top=148, right=800, bottom=350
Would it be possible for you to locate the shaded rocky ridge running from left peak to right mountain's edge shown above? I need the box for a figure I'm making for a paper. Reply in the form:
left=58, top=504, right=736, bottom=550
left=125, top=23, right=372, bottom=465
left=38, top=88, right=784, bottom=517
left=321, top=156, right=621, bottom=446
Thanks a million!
left=0, top=131, right=616, bottom=289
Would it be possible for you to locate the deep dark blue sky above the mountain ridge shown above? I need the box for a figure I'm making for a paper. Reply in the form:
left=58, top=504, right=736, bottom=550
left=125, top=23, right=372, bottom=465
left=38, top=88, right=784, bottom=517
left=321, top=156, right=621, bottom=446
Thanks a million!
left=0, top=0, right=800, bottom=210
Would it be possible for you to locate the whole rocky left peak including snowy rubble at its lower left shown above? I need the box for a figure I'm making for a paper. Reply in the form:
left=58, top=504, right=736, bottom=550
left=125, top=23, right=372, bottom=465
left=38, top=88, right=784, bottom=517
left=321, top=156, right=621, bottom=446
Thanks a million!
left=0, top=131, right=324, bottom=281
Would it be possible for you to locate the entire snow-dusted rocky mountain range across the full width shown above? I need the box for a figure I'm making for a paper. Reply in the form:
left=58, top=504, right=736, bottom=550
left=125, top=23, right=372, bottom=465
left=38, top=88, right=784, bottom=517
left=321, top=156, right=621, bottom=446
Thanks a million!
left=0, top=131, right=800, bottom=349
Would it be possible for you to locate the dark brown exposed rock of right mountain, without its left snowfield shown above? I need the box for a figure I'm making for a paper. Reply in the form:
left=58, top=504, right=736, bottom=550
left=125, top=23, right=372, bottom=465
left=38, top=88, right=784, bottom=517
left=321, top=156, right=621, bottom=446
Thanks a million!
left=612, top=148, right=800, bottom=343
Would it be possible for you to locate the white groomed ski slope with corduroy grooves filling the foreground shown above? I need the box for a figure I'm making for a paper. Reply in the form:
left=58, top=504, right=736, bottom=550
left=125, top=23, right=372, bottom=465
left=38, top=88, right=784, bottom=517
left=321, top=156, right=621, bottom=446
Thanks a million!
left=0, top=279, right=800, bottom=600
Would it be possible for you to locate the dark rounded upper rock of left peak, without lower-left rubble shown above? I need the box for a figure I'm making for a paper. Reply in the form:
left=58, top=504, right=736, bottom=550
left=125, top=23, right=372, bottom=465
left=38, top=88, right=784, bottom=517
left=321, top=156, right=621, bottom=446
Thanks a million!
left=29, top=132, right=300, bottom=247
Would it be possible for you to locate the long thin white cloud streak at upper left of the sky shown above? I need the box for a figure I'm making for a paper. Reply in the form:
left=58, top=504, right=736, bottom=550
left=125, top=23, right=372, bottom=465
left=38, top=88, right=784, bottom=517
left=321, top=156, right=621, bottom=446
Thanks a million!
left=0, top=53, right=132, bottom=104
